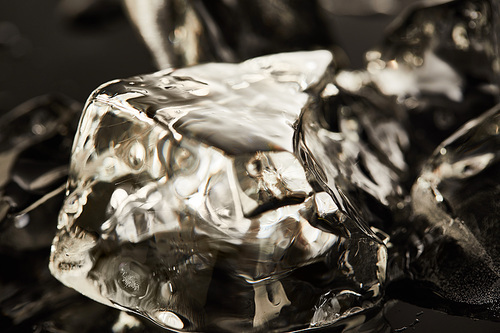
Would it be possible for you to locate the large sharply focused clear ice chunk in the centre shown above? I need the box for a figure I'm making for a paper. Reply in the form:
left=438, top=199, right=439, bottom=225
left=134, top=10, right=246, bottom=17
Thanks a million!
left=50, top=51, right=387, bottom=331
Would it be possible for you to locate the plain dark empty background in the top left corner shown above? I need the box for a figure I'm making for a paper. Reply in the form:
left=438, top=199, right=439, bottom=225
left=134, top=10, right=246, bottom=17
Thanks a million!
left=0, top=0, right=155, bottom=111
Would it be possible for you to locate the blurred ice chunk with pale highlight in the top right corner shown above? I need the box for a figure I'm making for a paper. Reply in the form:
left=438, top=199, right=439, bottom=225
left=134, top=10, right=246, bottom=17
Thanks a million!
left=366, top=0, right=500, bottom=155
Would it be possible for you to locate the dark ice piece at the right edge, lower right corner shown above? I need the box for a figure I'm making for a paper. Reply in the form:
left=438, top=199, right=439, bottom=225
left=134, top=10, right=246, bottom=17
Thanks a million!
left=410, top=106, right=500, bottom=319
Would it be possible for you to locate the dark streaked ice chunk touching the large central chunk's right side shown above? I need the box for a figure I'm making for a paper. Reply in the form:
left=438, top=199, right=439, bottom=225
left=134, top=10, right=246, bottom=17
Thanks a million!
left=298, top=83, right=409, bottom=230
